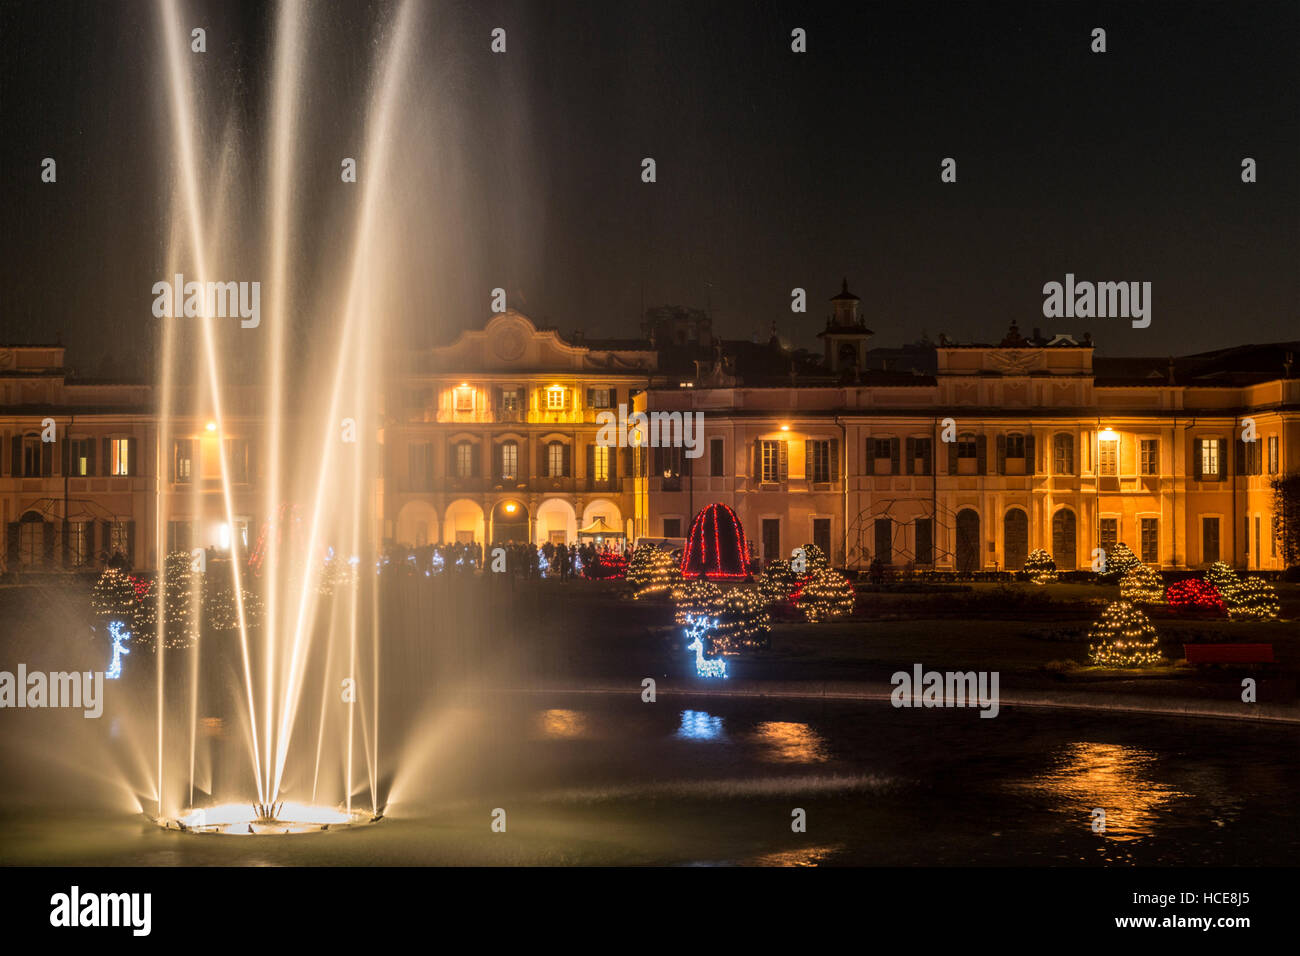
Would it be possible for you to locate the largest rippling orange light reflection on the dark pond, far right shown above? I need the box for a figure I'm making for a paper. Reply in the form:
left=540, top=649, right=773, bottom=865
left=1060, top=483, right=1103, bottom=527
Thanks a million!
left=1015, top=743, right=1187, bottom=842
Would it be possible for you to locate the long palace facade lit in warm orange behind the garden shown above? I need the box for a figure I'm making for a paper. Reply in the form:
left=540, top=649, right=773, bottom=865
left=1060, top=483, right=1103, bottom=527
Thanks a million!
left=0, top=284, right=1300, bottom=571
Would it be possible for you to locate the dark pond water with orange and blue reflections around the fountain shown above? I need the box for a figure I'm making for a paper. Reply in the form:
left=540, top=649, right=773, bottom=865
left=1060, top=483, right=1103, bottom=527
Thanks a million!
left=0, top=693, right=1300, bottom=865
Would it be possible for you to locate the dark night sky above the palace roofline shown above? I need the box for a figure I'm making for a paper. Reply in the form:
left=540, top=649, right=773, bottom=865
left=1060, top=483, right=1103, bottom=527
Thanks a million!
left=0, top=0, right=1300, bottom=375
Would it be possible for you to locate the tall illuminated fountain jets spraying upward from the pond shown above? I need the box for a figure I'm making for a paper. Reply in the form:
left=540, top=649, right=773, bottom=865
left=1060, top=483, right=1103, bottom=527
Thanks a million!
left=124, top=0, right=416, bottom=834
